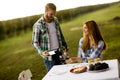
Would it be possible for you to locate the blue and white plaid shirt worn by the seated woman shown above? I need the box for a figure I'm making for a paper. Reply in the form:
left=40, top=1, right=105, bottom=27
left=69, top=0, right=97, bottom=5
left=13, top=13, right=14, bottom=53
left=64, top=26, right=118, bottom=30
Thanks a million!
left=78, top=38, right=104, bottom=62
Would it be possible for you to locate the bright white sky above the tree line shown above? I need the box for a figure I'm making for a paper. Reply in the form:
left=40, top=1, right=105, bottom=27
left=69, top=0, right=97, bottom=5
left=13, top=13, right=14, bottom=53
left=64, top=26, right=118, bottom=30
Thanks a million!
left=0, top=0, right=119, bottom=21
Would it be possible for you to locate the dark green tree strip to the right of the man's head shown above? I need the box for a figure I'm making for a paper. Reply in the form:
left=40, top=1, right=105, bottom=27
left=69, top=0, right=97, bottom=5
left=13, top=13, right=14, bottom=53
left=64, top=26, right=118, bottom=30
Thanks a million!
left=56, top=3, right=113, bottom=22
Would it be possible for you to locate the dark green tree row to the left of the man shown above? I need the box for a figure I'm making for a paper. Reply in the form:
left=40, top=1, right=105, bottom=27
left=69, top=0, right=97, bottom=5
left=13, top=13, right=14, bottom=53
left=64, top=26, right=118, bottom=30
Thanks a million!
left=0, top=15, right=41, bottom=40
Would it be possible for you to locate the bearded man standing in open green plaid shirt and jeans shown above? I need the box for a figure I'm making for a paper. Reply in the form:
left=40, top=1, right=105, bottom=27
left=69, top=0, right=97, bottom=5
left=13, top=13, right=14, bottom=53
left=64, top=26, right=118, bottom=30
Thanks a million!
left=32, top=3, right=67, bottom=71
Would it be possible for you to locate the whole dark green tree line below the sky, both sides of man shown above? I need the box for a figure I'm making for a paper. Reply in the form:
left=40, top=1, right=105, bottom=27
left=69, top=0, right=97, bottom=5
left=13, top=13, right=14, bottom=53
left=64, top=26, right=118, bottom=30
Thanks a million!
left=0, top=2, right=118, bottom=40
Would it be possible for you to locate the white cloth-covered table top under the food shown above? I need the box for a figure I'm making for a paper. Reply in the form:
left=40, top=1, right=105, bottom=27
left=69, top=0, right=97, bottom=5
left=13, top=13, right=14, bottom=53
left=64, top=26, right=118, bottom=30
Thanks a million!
left=42, top=59, right=119, bottom=80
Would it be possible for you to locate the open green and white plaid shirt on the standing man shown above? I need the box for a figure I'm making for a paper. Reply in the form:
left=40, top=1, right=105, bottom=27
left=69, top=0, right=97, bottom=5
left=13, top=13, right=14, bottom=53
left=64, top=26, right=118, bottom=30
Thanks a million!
left=32, top=17, right=67, bottom=54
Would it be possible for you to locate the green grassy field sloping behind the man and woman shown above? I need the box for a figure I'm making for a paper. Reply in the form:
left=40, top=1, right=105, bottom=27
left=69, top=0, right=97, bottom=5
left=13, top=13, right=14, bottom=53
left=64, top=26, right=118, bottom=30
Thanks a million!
left=0, top=3, right=120, bottom=80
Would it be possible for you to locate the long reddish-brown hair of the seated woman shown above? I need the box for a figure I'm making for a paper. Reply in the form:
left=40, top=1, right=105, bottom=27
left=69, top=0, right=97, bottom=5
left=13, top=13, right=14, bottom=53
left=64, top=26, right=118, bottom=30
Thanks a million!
left=82, top=20, right=106, bottom=52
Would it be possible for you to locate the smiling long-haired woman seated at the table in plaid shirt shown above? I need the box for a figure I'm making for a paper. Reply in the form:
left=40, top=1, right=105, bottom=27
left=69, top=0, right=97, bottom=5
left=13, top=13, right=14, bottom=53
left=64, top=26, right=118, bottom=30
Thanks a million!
left=67, top=20, right=106, bottom=63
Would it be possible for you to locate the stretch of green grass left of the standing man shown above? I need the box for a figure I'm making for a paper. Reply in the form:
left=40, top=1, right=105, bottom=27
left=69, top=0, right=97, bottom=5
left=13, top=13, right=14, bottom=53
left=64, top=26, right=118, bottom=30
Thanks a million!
left=0, top=32, right=46, bottom=80
